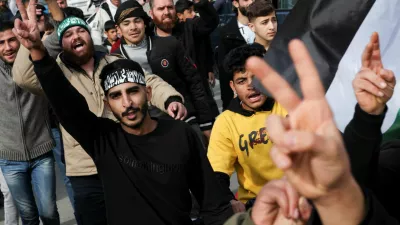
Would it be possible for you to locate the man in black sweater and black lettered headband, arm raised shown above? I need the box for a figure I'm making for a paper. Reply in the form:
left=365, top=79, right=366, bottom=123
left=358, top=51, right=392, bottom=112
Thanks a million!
left=16, top=0, right=232, bottom=225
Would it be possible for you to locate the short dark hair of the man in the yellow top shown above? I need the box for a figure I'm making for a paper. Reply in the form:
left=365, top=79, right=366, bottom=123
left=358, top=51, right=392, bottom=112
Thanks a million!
left=224, top=44, right=267, bottom=80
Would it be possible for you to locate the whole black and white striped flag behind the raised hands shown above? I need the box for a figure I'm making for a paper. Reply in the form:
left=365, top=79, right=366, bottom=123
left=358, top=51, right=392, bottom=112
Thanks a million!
left=254, top=0, right=400, bottom=139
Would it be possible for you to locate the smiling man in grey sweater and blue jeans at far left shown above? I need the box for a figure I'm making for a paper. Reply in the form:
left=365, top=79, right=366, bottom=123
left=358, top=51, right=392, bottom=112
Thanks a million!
left=0, top=20, right=60, bottom=225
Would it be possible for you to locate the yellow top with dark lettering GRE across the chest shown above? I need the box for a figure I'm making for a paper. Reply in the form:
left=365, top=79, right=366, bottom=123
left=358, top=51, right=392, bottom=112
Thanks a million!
left=207, top=98, right=287, bottom=203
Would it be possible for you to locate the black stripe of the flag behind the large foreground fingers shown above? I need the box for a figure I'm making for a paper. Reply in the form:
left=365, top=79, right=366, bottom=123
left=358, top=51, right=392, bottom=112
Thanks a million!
left=254, top=0, right=375, bottom=95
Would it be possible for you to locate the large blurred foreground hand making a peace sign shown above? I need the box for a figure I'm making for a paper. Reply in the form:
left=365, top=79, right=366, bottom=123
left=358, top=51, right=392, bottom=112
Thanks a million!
left=246, top=40, right=364, bottom=224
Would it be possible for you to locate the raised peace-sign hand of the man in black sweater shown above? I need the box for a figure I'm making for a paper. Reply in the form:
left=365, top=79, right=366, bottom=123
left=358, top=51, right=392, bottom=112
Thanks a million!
left=13, top=0, right=43, bottom=50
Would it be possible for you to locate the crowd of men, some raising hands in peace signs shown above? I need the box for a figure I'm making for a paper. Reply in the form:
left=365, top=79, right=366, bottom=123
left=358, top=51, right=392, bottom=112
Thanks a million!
left=0, top=0, right=400, bottom=225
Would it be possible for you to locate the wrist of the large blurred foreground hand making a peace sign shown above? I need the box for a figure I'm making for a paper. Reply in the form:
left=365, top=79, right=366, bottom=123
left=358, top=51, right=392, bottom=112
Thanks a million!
left=313, top=176, right=366, bottom=225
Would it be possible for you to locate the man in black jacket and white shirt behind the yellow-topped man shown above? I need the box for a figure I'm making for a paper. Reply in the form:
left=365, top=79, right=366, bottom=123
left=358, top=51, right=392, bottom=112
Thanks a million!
left=217, top=0, right=255, bottom=110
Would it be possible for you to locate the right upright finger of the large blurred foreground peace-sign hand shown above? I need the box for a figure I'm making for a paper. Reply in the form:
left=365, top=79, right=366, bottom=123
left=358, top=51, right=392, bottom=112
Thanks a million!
left=289, top=40, right=325, bottom=100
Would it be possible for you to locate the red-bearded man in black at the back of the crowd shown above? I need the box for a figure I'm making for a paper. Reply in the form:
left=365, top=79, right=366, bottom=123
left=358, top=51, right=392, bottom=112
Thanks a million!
left=149, top=0, right=219, bottom=139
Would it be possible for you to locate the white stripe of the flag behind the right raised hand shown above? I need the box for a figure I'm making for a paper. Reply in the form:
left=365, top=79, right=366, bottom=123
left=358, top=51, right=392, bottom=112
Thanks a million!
left=326, top=0, right=400, bottom=132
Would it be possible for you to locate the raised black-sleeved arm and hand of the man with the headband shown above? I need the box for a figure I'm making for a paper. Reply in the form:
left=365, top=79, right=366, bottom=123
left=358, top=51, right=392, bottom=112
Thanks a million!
left=13, top=0, right=109, bottom=159
